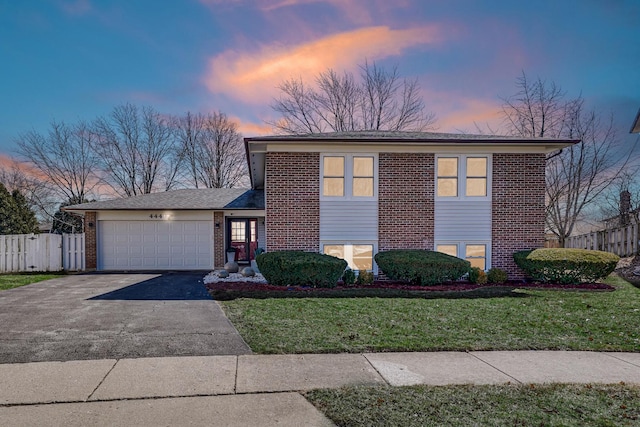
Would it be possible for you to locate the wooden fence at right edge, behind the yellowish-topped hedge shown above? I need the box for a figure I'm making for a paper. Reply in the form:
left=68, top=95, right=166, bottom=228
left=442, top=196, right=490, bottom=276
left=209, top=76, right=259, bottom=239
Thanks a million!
left=564, top=224, right=640, bottom=257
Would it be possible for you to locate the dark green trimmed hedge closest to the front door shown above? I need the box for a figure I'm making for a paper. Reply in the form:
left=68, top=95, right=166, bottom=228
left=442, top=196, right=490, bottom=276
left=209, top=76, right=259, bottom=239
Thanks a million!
left=256, top=251, right=347, bottom=288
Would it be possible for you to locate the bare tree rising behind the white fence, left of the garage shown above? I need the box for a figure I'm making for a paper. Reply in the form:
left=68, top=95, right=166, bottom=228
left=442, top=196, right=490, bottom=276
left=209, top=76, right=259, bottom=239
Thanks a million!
left=16, top=122, right=98, bottom=207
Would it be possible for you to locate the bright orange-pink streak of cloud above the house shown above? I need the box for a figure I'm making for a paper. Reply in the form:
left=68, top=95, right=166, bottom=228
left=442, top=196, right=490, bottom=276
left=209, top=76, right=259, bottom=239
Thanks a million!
left=203, top=26, right=441, bottom=104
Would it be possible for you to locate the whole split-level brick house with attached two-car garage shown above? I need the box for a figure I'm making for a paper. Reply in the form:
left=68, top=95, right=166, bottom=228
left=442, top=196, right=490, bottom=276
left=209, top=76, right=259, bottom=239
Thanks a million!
left=66, top=132, right=578, bottom=278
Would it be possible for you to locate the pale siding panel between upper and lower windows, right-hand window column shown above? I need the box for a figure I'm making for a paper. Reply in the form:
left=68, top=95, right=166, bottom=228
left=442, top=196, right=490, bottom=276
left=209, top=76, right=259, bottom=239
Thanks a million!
left=434, top=200, right=491, bottom=242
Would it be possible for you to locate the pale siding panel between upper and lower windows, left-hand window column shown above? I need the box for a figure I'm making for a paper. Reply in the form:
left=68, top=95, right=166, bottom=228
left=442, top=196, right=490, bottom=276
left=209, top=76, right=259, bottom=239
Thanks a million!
left=320, top=200, right=378, bottom=241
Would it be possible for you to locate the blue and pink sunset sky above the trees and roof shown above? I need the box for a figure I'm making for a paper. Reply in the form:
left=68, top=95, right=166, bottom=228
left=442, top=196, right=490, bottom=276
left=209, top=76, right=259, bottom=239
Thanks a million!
left=0, top=0, right=640, bottom=160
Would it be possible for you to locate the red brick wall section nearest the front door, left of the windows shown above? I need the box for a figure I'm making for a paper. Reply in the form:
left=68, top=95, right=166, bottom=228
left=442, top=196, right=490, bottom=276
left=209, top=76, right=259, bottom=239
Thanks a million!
left=265, top=153, right=320, bottom=252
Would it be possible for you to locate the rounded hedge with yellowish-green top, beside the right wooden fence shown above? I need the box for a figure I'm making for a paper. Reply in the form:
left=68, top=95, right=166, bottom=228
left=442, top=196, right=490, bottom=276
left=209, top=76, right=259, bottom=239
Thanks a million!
left=513, top=248, right=620, bottom=285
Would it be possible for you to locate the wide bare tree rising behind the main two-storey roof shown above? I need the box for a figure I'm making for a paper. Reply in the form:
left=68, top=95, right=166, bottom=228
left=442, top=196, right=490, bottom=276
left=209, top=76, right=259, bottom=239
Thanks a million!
left=269, top=62, right=435, bottom=134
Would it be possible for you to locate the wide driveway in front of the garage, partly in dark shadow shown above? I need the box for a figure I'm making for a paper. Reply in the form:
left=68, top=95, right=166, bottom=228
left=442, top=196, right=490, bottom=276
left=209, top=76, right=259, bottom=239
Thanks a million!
left=0, top=272, right=251, bottom=363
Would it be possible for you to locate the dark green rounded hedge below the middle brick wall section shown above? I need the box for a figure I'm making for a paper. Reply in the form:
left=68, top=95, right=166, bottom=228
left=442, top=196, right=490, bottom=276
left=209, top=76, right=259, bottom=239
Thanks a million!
left=374, top=249, right=471, bottom=286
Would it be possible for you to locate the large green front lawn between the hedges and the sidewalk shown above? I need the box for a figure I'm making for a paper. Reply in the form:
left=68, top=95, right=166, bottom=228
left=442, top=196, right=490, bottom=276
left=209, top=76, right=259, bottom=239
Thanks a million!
left=220, top=276, right=640, bottom=353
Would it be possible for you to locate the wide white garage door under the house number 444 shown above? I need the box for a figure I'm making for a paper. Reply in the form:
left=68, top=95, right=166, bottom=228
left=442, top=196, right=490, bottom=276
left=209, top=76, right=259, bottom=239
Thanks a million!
left=98, top=221, right=213, bottom=270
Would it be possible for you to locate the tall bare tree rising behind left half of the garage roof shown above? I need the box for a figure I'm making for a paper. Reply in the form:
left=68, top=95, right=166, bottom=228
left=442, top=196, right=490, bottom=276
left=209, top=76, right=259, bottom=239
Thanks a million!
left=92, top=104, right=179, bottom=196
